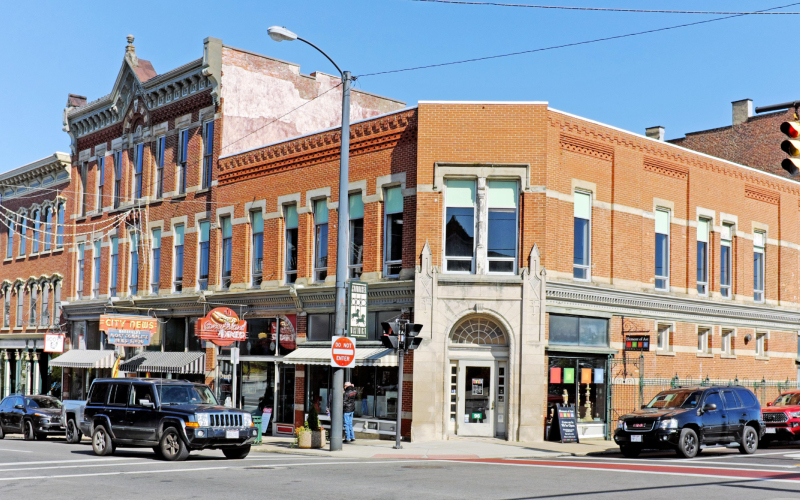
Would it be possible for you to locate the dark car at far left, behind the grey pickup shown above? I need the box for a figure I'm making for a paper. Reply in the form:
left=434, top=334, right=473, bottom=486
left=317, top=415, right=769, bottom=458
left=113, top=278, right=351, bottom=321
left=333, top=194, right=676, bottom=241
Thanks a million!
left=0, top=394, right=64, bottom=441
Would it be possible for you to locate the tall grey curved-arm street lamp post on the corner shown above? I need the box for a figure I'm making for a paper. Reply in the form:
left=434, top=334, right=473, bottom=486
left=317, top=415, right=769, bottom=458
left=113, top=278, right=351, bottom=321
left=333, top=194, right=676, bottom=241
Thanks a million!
left=267, top=26, right=352, bottom=451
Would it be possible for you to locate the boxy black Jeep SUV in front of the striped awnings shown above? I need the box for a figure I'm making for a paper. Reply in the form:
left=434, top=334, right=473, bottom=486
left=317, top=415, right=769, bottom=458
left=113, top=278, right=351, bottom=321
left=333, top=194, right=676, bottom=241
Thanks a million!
left=79, top=378, right=258, bottom=460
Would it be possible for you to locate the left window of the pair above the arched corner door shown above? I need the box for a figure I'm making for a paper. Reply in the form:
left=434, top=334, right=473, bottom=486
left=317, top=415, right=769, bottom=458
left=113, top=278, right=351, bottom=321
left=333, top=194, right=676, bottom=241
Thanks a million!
left=444, top=179, right=475, bottom=273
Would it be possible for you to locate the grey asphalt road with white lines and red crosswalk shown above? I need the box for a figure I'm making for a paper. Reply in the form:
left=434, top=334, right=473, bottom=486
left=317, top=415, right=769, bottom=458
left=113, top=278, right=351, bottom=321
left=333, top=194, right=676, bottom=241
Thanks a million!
left=0, top=437, right=800, bottom=500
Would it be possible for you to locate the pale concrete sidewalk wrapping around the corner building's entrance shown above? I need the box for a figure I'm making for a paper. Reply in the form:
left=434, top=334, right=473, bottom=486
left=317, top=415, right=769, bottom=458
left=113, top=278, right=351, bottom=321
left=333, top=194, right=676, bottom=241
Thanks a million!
left=253, top=436, right=619, bottom=460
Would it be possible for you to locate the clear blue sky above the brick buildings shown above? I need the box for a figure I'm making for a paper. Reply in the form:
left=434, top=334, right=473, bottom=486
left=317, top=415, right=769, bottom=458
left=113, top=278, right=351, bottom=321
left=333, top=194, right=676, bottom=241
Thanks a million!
left=0, top=0, right=800, bottom=171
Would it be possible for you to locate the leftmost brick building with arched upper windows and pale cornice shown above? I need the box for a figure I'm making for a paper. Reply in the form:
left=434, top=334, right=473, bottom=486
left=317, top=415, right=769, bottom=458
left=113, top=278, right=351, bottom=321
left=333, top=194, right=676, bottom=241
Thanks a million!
left=0, top=153, right=70, bottom=397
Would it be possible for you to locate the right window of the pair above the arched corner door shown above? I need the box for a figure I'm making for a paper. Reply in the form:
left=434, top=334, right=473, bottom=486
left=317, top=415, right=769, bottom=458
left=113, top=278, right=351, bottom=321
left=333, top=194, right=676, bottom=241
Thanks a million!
left=486, top=180, right=519, bottom=274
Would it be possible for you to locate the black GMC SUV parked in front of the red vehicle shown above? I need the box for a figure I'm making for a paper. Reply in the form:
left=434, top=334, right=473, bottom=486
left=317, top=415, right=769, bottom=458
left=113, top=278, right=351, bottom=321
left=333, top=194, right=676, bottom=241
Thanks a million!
left=614, top=387, right=765, bottom=458
